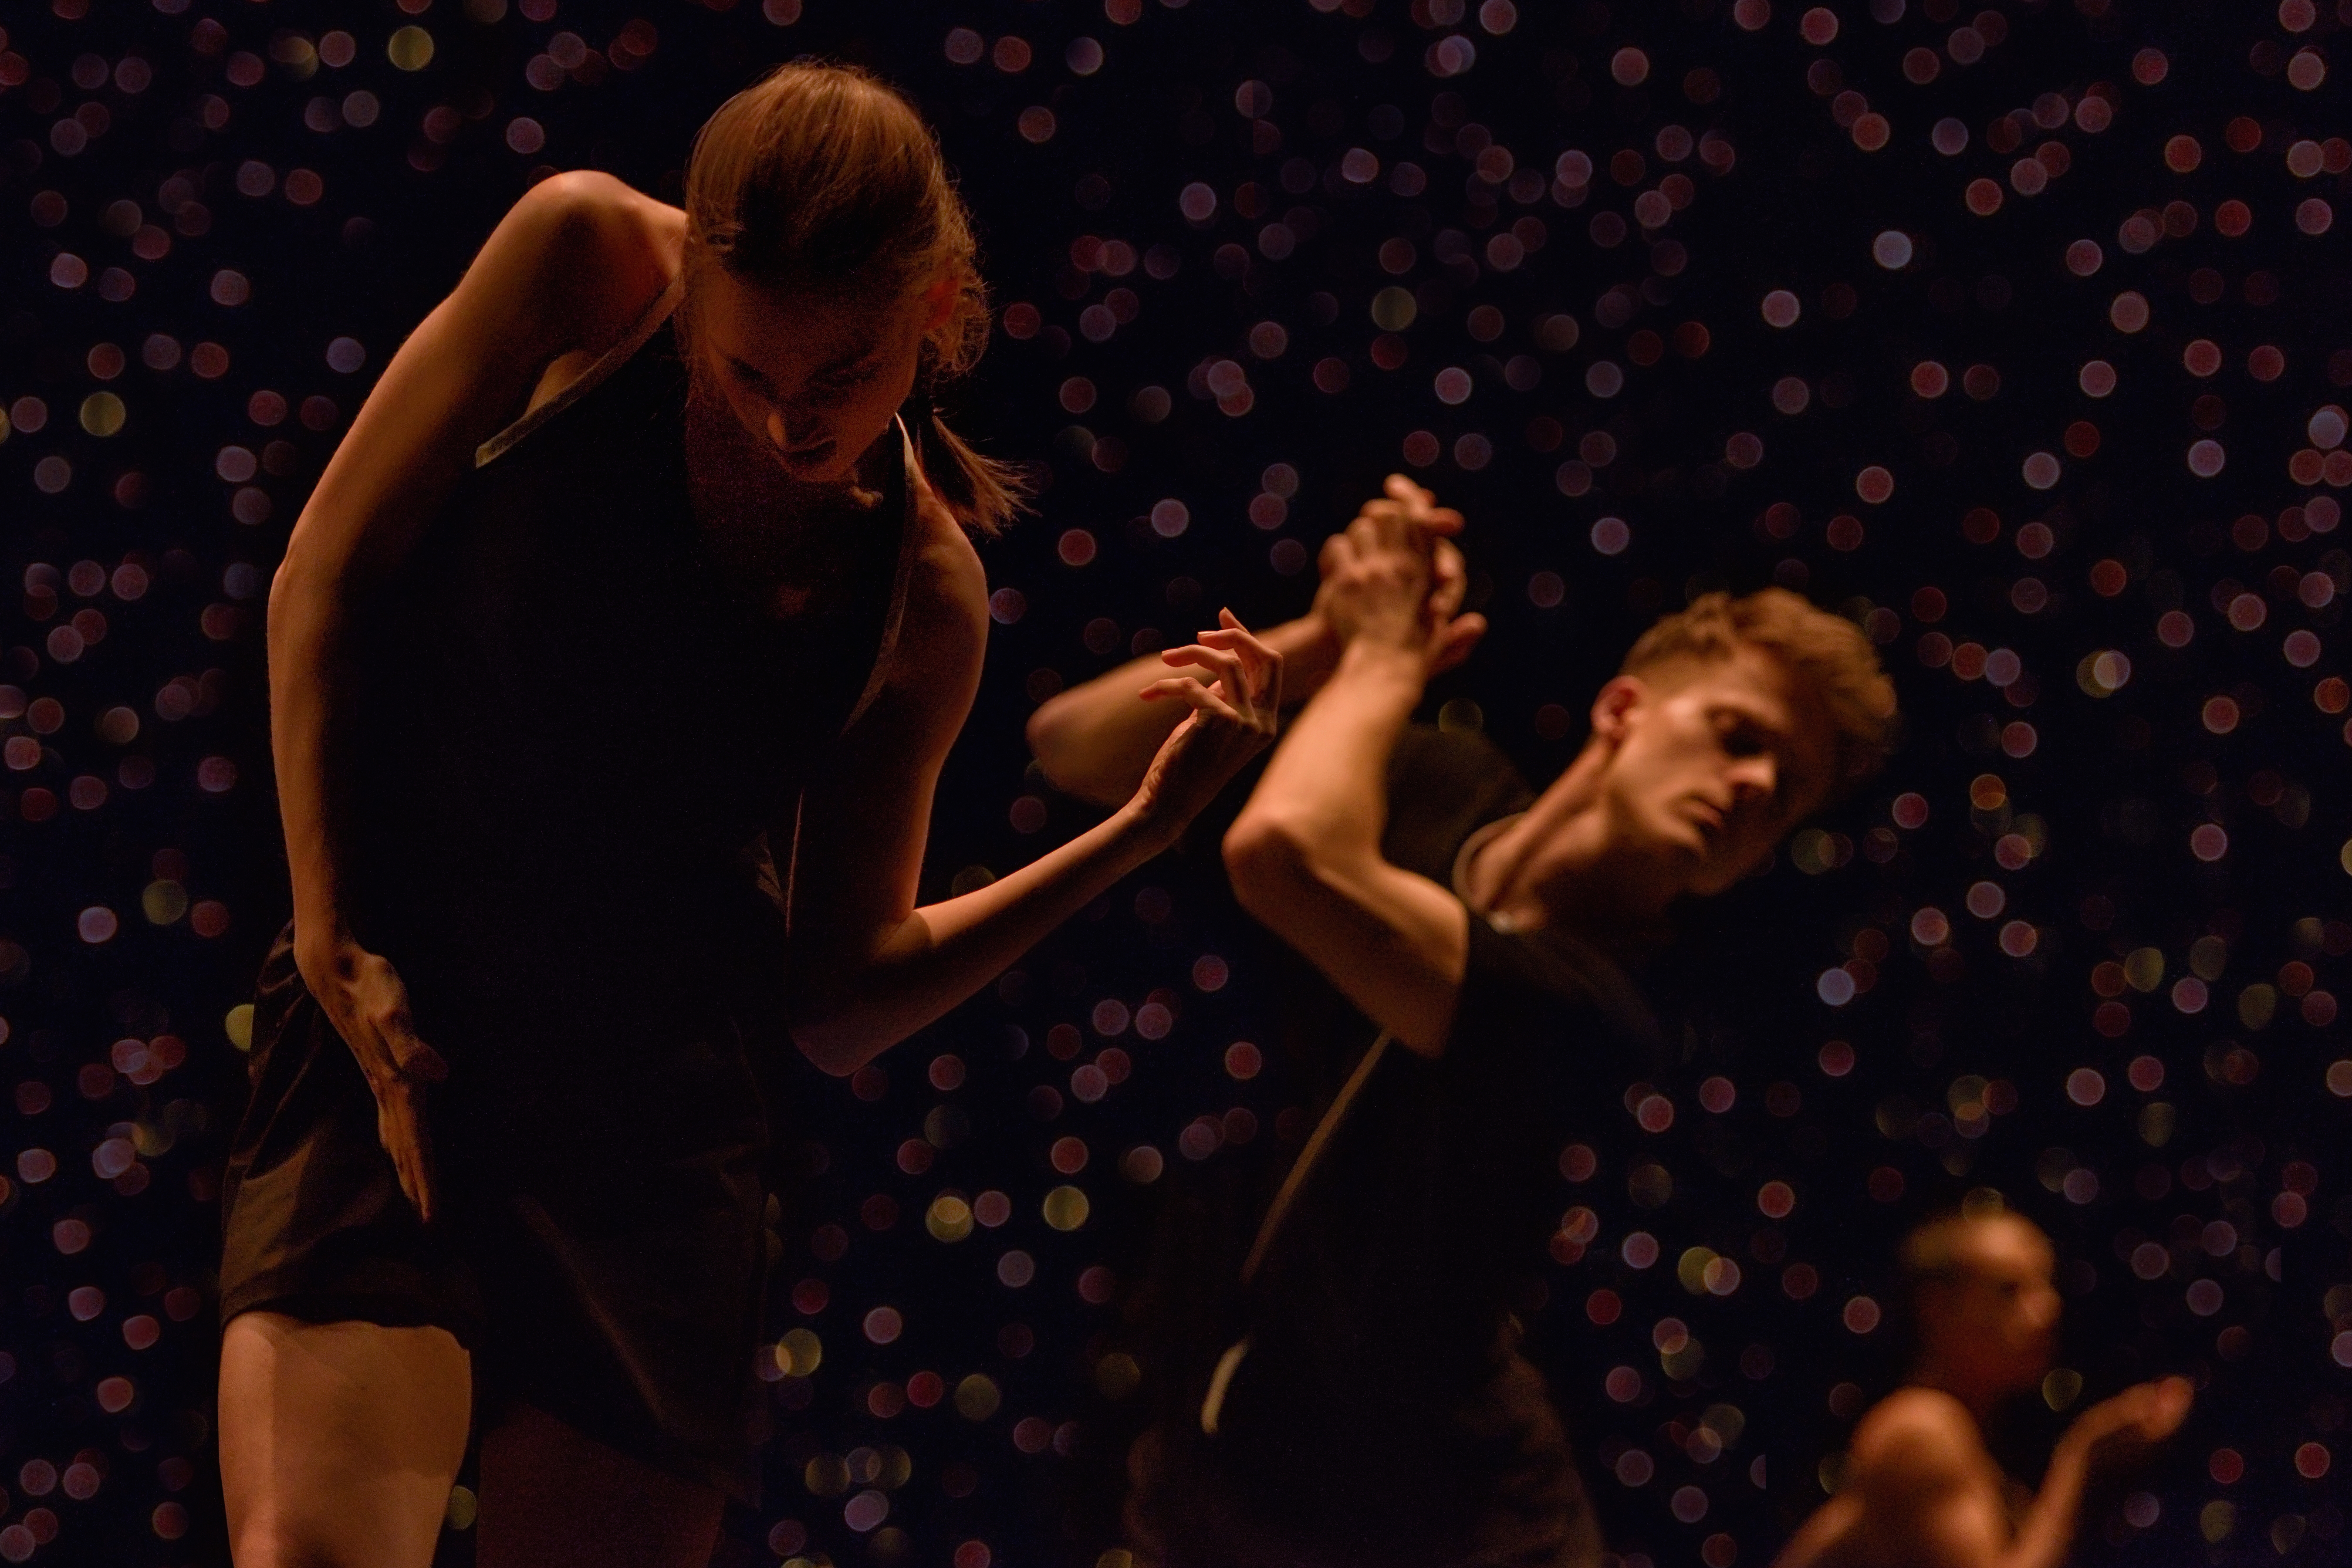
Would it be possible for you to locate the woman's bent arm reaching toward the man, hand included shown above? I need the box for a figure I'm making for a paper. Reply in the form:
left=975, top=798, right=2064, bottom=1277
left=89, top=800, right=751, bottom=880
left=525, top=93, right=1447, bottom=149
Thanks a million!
left=776, top=491, right=1282, bottom=1072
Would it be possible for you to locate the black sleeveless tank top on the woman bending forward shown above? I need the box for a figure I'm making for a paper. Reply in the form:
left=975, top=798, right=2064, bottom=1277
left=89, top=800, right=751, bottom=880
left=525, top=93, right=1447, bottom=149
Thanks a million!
left=346, top=284, right=915, bottom=1077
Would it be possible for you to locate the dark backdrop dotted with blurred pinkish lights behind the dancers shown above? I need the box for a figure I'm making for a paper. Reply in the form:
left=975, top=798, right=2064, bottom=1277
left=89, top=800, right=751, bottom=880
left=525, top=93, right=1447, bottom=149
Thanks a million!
left=0, top=0, right=2352, bottom=1568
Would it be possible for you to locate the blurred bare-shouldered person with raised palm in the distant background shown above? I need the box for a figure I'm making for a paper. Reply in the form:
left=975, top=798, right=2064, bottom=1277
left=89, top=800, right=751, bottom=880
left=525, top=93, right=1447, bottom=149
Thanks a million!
left=1778, top=1211, right=2190, bottom=1568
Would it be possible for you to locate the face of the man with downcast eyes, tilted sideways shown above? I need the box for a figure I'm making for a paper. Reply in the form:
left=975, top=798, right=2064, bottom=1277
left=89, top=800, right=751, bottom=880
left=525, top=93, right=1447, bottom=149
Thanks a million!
left=1595, top=644, right=1835, bottom=898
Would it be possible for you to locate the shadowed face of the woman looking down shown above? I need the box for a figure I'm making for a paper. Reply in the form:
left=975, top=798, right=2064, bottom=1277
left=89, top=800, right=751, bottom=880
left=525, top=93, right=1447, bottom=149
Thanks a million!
left=694, top=266, right=955, bottom=484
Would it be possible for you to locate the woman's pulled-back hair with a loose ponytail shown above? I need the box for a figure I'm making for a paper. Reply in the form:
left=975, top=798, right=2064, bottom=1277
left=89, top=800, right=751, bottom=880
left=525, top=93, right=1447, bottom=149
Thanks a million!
left=682, top=61, right=1025, bottom=534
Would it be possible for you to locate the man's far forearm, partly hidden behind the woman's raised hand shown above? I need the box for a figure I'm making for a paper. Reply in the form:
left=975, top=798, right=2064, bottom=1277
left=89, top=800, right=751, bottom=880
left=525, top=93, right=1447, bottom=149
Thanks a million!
left=1028, top=614, right=1338, bottom=806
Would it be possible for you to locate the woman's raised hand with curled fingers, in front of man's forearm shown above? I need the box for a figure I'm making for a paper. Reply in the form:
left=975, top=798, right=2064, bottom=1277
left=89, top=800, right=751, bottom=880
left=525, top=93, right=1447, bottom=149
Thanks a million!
left=1131, top=609, right=1282, bottom=839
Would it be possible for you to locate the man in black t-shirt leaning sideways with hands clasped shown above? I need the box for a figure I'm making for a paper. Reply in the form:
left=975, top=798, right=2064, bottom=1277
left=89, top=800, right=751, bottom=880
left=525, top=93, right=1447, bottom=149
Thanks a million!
left=1030, top=496, right=1893, bottom=1568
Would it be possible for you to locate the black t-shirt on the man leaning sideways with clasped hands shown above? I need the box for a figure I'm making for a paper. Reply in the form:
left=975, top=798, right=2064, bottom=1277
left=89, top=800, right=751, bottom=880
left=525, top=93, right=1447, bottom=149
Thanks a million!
left=1138, top=727, right=1651, bottom=1561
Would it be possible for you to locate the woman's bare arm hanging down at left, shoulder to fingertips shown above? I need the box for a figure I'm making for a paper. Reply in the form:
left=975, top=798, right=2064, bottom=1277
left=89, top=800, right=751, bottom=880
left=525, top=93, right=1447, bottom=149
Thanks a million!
left=268, top=176, right=661, bottom=1213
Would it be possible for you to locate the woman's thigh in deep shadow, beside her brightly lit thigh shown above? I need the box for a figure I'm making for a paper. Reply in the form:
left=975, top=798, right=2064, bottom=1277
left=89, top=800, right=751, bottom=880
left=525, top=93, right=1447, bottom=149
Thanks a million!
left=475, top=1403, right=727, bottom=1568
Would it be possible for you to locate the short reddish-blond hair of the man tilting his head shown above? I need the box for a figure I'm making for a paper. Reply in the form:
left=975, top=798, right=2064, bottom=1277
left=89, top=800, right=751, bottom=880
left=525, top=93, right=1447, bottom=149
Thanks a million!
left=1621, top=588, right=1896, bottom=797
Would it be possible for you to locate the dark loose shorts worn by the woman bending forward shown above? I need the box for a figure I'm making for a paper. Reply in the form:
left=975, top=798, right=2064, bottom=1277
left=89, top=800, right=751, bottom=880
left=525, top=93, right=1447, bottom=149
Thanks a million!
left=221, top=933, right=769, bottom=1502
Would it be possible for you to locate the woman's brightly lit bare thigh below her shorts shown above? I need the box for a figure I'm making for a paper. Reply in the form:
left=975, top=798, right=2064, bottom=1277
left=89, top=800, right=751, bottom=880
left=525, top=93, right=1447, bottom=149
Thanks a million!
left=221, top=1312, right=473, bottom=1568
